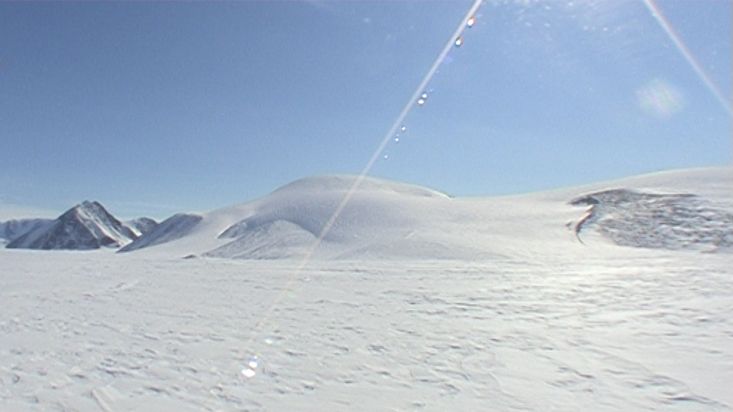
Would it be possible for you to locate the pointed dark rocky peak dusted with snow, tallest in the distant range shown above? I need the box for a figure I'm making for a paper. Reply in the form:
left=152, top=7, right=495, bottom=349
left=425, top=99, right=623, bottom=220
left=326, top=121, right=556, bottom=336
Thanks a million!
left=7, top=201, right=138, bottom=250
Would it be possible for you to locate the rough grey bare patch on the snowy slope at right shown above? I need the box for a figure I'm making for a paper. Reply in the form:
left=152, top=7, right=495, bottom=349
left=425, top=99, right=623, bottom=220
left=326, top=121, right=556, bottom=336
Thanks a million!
left=572, top=189, right=733, bottom=251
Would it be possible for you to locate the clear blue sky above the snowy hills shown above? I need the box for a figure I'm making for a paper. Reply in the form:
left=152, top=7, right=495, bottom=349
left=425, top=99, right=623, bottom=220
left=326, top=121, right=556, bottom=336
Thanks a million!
left=0, top=0, right=733, bottom=218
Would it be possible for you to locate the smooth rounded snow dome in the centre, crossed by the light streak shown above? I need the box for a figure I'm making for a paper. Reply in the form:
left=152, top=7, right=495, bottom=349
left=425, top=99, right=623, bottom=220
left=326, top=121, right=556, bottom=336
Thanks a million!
left=206, top=176, right=450, bottom=259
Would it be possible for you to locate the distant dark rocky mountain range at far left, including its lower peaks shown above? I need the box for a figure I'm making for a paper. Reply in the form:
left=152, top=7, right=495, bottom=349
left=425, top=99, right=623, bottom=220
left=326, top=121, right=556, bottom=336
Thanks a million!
left=0, top=201, right=157, bottom=250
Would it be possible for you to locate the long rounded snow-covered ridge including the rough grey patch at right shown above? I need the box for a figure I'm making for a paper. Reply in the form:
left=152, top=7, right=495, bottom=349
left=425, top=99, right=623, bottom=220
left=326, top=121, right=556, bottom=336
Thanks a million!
left=122, top=167, right=733, bottom=260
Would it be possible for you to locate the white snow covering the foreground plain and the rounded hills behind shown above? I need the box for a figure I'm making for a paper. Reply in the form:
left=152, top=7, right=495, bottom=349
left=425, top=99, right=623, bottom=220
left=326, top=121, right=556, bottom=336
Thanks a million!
left=0, top=168, right=733, bottom=411
